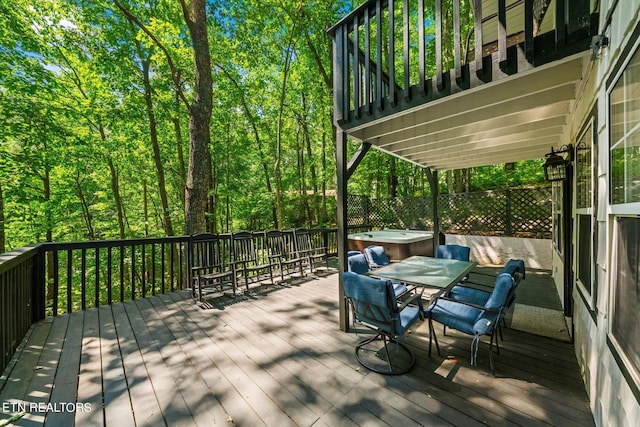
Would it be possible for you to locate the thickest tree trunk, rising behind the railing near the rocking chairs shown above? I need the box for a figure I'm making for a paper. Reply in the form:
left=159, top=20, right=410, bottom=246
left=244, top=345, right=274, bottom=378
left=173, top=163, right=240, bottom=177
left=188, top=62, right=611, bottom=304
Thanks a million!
left=182, top=0, right=213, bottom=234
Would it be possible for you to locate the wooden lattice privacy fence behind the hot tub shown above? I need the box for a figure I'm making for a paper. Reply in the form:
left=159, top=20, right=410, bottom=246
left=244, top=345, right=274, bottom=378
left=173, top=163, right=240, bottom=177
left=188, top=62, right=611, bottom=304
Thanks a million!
left=347, top=187, right=552, bottom=239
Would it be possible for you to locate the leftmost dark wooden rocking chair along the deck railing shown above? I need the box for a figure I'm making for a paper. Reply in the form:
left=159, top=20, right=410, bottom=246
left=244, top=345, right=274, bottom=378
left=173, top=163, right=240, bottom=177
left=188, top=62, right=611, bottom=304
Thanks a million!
left=190, top=234, right=237, bottom=302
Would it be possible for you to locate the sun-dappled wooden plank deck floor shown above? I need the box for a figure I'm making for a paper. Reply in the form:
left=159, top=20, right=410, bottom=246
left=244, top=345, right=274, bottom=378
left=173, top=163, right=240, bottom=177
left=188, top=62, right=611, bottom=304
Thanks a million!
left=0, top=274, right=593, bottom=427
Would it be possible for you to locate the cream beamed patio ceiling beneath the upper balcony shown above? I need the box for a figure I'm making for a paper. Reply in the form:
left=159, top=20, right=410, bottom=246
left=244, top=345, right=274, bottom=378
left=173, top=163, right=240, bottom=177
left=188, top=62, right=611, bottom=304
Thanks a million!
left=346, top=52, right=589, bottom=170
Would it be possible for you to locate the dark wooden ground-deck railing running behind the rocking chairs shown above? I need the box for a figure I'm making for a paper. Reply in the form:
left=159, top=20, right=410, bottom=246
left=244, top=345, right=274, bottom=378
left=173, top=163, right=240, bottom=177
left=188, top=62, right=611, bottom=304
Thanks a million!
left=0, top=228, right=338, bottom=371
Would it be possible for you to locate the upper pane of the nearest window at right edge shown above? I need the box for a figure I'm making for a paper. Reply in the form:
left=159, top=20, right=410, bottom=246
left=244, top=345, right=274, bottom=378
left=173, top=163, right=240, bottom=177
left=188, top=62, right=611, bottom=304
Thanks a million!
left=609, top=51, right=640, bottom=205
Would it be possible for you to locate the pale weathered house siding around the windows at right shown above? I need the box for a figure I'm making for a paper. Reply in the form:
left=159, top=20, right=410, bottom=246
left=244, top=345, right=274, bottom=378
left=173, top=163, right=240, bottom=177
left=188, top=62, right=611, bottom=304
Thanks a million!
left=568, top=0, right=640, bottom=427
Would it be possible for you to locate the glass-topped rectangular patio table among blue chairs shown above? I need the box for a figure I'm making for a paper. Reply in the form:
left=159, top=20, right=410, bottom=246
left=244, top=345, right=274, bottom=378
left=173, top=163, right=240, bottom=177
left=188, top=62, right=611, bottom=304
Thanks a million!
left=369, top=255, right=478, bottom=293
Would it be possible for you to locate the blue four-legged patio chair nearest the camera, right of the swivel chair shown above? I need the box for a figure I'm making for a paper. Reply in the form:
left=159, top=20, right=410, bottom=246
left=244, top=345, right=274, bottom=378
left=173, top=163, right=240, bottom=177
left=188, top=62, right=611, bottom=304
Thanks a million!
left=424, top=273, right=522, bottom=376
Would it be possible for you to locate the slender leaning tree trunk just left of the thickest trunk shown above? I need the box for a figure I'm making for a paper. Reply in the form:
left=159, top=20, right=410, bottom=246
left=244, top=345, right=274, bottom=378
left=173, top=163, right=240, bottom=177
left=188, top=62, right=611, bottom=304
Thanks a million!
left=138, top=56, right=173, bottom=236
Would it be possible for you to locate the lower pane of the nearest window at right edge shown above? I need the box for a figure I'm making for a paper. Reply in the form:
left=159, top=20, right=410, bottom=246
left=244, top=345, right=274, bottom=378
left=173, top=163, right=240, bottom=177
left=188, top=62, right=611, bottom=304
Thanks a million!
left=611, top=217, right=640, bottom=377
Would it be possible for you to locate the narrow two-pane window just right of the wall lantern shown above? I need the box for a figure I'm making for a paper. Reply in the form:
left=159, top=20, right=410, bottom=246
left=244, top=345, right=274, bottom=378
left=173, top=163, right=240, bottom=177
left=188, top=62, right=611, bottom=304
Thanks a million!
left=575, top=120, right=597, bottom=300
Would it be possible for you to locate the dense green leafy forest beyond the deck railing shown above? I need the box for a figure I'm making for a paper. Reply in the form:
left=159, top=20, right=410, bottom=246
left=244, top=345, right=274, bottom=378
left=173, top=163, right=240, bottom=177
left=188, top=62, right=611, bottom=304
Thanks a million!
left=0, top=0, right=543, bottom=253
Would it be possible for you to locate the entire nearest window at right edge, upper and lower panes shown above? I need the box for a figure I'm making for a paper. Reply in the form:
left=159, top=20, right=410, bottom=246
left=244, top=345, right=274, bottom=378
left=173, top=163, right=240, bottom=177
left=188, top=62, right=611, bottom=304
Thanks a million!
left=608, top=41, right=640, bottom=393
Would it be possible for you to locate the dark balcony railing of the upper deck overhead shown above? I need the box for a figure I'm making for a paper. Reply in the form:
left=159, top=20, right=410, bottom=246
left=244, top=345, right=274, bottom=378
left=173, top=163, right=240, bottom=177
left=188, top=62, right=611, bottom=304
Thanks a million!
left=329, top=0, right=598, bottom=129
